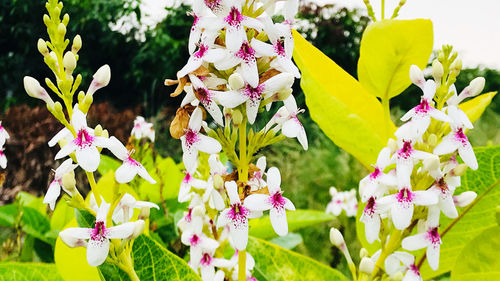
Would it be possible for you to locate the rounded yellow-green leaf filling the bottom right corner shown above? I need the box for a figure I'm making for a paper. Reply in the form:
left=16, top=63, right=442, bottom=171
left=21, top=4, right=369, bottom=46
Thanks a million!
left=451, top=226, right=500, bottom=281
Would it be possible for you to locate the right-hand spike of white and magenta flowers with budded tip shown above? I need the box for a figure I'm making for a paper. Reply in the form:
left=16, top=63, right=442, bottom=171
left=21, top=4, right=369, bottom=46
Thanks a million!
left=359, top=52, right=485, bottom=280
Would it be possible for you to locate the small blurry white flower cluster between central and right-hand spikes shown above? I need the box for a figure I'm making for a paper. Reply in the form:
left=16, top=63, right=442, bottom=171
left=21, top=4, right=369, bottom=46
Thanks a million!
left=326, top=186, right=358, bottom=217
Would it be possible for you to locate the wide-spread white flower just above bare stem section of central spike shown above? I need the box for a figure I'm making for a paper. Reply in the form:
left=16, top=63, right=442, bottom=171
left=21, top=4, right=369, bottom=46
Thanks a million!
left=217, top=73, right=294, bottom=123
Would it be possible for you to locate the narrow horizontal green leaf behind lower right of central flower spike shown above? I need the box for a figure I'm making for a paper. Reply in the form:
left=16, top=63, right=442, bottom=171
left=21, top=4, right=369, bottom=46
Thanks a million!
left=249, top=210, right=335, bottom=239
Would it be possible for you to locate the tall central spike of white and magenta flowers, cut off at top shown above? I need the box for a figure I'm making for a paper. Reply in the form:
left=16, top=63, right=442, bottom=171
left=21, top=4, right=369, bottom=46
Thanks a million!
left=169, top=0, right=308, bottom=280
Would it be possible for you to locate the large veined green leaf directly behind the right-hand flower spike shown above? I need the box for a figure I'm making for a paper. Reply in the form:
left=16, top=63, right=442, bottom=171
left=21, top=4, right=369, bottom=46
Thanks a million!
left=420, top=146, right=500, bottom=279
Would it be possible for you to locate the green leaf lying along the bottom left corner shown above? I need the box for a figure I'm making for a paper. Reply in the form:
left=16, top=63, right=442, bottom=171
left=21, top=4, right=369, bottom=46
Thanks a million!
left=0, top=262, right=63, bottom=281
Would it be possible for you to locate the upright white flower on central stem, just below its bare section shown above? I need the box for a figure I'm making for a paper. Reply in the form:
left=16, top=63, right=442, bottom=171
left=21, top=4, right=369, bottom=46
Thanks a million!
left=217, top=181, right=250, bottom=250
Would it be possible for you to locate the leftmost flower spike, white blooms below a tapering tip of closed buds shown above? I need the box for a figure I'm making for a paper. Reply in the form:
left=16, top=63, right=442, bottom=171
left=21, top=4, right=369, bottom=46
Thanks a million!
left=22, top=0, right=158, bottom=274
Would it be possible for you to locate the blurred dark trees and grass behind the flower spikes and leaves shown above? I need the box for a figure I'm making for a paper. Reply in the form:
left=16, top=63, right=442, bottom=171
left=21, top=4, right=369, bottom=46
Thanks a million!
left=0, top=0, right=500, bottom=274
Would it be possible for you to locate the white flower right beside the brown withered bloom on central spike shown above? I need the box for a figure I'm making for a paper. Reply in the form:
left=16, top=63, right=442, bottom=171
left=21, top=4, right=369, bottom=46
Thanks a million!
left=181, top=107, right=222, bottom=174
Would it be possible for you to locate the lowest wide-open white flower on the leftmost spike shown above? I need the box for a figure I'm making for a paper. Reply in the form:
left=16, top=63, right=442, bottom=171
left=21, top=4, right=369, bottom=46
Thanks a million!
left=59, top=201, right=136, bottom=266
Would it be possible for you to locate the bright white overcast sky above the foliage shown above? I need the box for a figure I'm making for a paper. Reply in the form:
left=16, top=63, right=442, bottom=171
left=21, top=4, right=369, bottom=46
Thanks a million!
left=135, top=0, right=500, bottom=70
